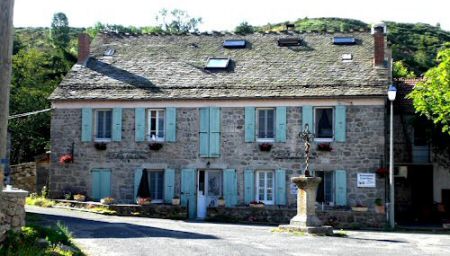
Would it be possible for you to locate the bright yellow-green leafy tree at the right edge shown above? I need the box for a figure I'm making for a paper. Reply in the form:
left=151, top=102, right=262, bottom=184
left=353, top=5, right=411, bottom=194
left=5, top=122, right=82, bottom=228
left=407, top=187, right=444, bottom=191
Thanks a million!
left=408, top=44, right=450, bottom=134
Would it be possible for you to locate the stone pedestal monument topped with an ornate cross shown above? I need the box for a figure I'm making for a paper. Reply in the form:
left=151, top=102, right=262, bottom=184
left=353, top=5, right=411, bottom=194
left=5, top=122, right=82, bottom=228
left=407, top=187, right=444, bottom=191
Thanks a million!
left=279, top=124, right=333, bottom=235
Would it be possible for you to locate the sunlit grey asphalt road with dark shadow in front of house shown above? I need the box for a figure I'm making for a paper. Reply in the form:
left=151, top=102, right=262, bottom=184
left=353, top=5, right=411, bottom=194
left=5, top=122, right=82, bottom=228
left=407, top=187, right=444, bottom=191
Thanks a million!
left=26, top=207, right=450, bottom=256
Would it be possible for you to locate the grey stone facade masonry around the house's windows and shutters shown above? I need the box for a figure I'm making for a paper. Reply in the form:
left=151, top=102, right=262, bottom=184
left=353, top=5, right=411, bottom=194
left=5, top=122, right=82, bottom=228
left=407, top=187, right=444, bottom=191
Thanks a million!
left=50, top=103, right=385, bottom=208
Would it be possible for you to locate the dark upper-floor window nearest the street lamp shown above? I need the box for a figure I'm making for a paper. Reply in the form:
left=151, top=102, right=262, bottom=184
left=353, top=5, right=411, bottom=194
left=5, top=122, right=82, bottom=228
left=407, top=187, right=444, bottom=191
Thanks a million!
left=314, top=107, right=334, bottom=141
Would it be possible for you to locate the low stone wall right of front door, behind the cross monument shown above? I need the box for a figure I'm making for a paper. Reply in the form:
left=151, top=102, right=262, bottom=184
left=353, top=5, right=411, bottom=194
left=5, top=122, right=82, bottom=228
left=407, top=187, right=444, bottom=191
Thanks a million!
left=207, top=206, right=386, bottom=229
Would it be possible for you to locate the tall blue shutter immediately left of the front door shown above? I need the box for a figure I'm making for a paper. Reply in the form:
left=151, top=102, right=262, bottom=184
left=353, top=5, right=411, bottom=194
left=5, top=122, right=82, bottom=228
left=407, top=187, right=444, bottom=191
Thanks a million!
left=181, top=169, right=197, bottom=219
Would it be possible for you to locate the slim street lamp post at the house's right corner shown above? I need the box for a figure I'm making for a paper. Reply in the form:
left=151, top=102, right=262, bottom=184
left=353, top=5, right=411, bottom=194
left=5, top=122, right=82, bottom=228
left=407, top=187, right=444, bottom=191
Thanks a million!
left=388, top=85, right=397, bottom=229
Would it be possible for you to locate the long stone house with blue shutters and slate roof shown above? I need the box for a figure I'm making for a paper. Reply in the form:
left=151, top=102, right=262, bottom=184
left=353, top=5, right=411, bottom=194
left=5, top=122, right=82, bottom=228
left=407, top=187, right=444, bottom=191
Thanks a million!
left=50, top=25, right=391, bottom=218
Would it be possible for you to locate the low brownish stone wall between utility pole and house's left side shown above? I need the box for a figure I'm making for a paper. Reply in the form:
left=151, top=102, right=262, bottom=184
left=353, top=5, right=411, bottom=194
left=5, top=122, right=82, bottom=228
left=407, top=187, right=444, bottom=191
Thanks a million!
left=10, top=162, right=36, bottom=193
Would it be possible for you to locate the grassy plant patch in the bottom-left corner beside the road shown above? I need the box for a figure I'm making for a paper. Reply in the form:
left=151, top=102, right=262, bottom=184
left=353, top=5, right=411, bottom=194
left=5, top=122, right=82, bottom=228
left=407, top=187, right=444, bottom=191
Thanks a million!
left=0, top=220, right=85, bottom=256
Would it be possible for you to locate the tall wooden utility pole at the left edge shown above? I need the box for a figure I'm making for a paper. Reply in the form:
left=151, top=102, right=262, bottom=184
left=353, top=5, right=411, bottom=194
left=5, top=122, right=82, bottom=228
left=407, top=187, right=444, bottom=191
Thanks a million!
left=0, top=0, right=14, bottom=189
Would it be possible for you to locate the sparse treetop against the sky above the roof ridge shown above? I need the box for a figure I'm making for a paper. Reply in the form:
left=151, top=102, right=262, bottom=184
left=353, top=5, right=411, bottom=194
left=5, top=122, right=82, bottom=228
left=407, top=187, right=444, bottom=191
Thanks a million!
left=156, top=9, right=202, bottom=33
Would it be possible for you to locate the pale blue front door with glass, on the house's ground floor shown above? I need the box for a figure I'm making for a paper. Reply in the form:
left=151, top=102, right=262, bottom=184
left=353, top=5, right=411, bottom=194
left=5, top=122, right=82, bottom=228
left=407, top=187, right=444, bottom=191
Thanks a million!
left=197, top=170, right=222, bottom=219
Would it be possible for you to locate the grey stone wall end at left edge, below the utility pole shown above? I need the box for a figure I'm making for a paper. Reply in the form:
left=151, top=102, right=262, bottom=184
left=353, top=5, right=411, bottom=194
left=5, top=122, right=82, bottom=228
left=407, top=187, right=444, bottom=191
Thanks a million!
left=0, top=190, right=28, bottom=242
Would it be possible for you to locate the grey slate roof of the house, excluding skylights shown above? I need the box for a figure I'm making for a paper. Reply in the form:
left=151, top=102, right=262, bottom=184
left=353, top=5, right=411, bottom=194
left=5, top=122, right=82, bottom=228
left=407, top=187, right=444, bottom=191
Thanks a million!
left=50, top=32, right=390, bottom=100
